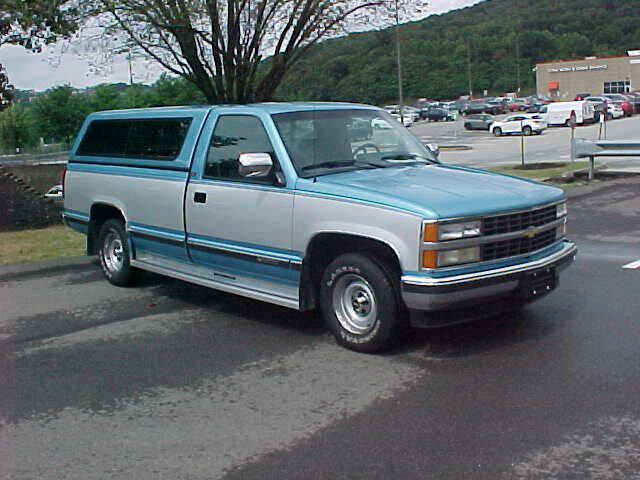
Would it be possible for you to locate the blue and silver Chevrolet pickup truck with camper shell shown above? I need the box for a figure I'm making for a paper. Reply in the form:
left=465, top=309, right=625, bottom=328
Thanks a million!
left=63, top=103, right=576, bottom=352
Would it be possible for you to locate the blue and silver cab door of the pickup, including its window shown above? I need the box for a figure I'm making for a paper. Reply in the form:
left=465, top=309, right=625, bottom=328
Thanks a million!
left=185, top=113, right=301, bottom=303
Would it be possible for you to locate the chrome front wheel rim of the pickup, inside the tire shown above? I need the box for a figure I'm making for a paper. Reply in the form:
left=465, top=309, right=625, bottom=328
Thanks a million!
left=332, top=273, right=378, bottom=335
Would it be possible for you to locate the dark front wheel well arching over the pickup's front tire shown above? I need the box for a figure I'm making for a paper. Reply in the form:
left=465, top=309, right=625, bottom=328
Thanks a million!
left=300, top=233, right=402, bottom=310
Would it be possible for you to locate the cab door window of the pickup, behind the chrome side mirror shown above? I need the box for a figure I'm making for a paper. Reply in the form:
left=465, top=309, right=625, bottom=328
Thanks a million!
left=203, top=115, right=276, bottom=184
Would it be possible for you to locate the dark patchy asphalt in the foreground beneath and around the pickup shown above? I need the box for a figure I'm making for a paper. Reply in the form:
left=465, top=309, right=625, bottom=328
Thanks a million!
left=0, top=179, right=640, bottom=480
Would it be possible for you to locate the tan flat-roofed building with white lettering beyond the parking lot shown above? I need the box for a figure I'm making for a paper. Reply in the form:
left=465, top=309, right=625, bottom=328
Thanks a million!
left=536, top=50, right=640, bottom=100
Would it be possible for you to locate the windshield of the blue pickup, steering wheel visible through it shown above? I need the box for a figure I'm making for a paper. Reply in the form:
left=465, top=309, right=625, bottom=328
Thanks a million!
left=272, top=109, right=436, bottom=178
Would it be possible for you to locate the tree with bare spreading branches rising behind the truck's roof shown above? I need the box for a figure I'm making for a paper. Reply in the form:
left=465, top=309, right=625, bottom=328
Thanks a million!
left=74, top=0, right=424, bottom=103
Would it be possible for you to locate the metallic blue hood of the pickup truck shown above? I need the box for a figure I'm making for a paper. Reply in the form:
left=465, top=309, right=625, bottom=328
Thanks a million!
left=298, top=164, right=564, bottom=220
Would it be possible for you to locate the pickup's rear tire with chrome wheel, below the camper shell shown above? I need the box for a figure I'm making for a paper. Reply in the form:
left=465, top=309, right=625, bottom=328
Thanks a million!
left=98, top=218, right=138, bottom=287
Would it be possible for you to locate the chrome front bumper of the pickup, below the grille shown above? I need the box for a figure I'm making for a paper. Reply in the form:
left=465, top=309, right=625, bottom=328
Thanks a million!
left=402, top=241, right=577, bottom=311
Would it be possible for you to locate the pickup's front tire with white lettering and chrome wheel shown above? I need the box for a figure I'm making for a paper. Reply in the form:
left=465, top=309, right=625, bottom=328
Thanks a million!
left=320, top=253, right=406, bottom=353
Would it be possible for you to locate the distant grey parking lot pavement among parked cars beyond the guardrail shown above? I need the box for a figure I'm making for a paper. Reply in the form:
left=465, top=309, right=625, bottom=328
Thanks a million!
left=411, top=115, right=640, bottom=167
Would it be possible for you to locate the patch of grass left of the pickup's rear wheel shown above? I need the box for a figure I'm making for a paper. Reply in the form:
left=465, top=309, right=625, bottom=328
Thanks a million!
left=0, top=225, right=86, bottom=265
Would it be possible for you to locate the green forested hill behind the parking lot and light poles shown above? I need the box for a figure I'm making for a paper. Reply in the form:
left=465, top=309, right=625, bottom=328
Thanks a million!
left=278, top=0, right=640, bottom=104
